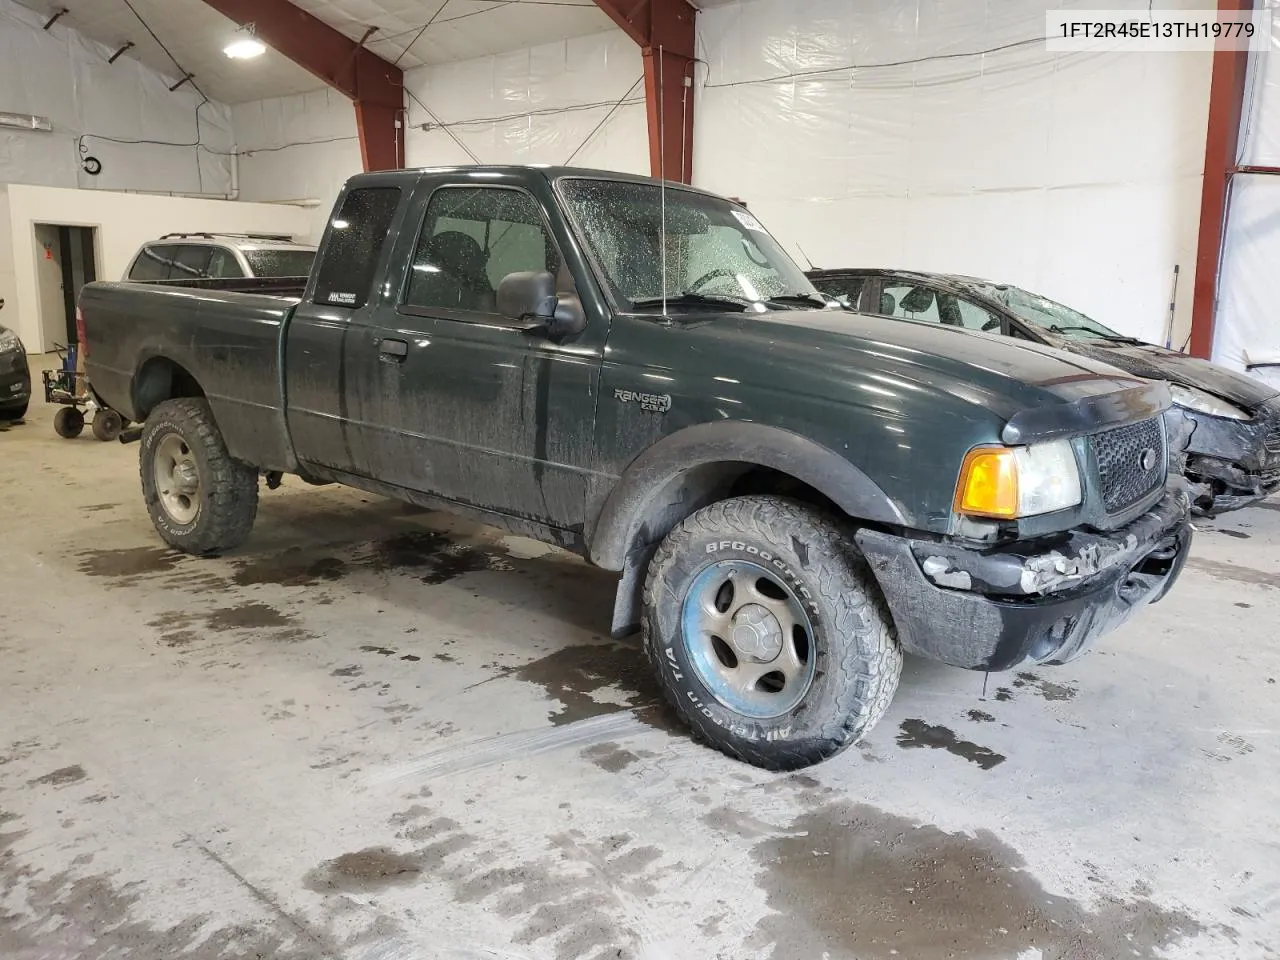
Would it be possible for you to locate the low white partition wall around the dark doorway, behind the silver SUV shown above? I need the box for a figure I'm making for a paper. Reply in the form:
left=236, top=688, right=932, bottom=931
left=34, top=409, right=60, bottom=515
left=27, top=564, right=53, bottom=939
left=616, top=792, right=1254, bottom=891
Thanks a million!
left=0, top=184, right=311, bottom=352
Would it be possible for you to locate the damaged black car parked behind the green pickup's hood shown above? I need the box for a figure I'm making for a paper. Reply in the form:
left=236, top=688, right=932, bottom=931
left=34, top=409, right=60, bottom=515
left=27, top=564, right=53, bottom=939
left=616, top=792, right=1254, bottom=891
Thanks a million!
left=809, top=270, right=1280, bottom=515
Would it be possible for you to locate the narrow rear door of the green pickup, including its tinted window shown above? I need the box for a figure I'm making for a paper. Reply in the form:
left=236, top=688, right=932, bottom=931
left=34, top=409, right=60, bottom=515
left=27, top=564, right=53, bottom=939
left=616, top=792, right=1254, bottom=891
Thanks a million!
left=283, top=186, right=406, bottom=474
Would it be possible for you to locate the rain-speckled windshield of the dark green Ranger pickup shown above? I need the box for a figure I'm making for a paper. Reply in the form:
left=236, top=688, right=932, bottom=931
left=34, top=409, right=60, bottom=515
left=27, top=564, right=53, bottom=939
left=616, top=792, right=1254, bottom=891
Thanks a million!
left=559, top=177, right=827, bottom=312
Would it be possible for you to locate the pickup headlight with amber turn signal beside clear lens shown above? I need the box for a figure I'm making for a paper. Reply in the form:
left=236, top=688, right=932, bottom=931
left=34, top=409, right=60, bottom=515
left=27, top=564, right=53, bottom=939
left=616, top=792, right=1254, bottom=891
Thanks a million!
left=955, top=440, right=1080, bottom=520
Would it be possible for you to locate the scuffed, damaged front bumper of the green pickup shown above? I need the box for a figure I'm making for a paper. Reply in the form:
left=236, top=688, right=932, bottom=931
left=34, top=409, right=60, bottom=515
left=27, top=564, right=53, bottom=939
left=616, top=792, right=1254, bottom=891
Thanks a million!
left=856, top=492, right=1192, bottom=671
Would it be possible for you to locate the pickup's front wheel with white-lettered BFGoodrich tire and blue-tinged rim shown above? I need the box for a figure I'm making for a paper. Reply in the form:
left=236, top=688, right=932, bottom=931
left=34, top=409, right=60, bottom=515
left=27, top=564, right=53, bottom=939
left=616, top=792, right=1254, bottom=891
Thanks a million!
left=643, top=497, right=902, bottom=771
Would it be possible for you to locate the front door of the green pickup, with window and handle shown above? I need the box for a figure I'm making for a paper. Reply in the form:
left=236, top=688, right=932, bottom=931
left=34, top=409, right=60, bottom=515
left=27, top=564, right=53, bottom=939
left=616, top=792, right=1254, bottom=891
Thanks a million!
left=348, top=180, right=605, bottom=529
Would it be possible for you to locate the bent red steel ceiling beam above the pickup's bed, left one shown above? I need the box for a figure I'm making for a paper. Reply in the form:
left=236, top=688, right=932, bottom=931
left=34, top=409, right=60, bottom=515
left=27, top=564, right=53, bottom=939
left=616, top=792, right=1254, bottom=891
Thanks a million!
left=205, top=0, right=404, bottom=170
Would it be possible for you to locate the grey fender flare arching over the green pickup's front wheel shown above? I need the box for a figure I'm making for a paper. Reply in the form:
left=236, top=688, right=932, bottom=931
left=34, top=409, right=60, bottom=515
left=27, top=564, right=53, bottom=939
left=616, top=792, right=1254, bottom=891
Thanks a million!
left=588, top=420, right=910, bottom=570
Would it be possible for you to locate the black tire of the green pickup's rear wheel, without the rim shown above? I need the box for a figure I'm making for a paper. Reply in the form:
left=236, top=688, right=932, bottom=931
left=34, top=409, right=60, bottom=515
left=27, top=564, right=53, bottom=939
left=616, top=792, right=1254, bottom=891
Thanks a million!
left=138, top=397, right=257, bottom=557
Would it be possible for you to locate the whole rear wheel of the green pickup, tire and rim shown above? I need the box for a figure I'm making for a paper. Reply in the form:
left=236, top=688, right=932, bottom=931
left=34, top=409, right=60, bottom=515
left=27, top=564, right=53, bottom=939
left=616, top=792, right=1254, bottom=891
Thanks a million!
left=140, top=398, right=257, bottom=556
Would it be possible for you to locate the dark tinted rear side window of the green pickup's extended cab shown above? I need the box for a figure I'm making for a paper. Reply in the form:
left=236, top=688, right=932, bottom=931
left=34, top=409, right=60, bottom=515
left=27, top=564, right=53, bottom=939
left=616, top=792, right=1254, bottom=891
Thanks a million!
left=315, top=187, right=401, bottom=307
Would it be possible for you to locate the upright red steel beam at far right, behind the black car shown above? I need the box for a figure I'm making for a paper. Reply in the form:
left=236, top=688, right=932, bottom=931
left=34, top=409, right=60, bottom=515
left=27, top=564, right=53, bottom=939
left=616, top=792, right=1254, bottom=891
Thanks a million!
left=1190, top=0, right=1253, bottom=360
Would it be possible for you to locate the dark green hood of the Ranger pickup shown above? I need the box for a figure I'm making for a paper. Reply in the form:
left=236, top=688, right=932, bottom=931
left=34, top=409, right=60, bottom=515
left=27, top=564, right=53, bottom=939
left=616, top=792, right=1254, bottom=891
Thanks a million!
left=714, top=310, right=1162, bottom=420
